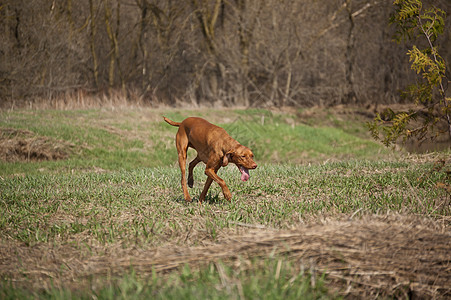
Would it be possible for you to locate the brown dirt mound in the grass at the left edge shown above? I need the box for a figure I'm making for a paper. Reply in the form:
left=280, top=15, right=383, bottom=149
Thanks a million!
left=0, top=128, right=74, bottom=162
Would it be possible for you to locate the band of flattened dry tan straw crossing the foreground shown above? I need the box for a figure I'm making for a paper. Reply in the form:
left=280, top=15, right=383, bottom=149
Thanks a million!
left=0, top=215, right=451, bottom=299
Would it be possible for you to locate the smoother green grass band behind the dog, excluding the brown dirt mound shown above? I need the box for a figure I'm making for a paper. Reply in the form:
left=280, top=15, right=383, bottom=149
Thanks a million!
left=0, top=109, right=389, bottom=176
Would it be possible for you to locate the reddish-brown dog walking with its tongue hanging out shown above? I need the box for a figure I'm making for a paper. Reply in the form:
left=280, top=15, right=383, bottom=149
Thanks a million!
left=163, top=117, right=257, bottom=203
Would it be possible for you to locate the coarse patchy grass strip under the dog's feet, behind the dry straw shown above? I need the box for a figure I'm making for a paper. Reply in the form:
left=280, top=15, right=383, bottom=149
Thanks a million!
left=0, top=161, right=448, bottom=245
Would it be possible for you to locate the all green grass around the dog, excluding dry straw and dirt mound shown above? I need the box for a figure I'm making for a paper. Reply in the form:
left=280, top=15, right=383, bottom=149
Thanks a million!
left=0, top=109, right=449, bottom=299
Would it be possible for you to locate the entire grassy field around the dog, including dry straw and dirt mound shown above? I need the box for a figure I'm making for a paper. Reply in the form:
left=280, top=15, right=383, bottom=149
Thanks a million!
left=0, top=108, right=451, bottom=299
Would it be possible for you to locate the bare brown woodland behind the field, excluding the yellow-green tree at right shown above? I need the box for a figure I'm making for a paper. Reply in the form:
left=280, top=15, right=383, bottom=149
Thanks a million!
left=0, top=0, right=451, bottom=107
